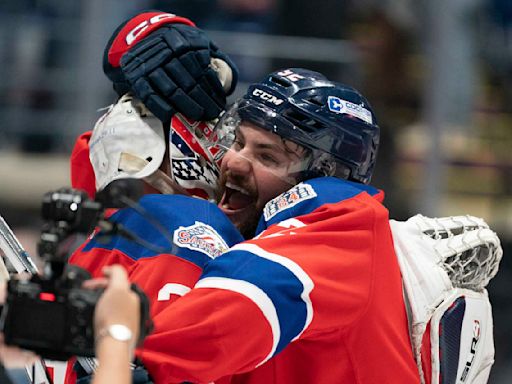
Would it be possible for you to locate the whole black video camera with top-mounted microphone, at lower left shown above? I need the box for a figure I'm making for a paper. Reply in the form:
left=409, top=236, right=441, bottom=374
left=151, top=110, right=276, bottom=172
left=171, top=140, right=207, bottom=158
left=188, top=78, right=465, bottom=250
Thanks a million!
left=0, top=180, right=151, bottom=361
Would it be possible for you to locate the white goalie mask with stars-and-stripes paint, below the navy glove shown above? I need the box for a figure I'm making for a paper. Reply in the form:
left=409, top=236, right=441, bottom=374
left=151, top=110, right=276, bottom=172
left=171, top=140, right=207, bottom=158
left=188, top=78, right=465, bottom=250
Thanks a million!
left=90, top=94, right=219, bottom=199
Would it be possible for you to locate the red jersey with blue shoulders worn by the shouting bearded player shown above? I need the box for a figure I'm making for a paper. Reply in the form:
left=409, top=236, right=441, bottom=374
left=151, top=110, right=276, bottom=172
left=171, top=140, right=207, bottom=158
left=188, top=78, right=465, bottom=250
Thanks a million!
left=140, top=178, right=419, bottom=384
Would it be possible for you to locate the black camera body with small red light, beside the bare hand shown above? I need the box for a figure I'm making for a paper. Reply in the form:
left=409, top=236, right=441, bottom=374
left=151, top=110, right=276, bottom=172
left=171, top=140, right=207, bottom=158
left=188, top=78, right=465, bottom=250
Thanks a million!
left=1, top=266, right=102, bottom=360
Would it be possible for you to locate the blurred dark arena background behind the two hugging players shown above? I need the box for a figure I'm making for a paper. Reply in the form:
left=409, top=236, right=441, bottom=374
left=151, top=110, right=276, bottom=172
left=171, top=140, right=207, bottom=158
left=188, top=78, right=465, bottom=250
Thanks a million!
left=0, top=0, right=512, bottom=384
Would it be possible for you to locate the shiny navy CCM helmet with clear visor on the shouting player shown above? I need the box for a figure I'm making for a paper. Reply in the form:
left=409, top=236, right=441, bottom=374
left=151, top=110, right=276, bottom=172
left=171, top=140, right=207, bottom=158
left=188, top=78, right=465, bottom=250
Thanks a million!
left=217, top=68, right=380, bottom=184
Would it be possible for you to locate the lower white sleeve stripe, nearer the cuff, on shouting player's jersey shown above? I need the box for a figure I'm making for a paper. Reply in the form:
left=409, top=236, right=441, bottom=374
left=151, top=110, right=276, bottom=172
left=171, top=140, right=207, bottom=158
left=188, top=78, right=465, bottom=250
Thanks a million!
left=194, top=277, right=281, bottom=366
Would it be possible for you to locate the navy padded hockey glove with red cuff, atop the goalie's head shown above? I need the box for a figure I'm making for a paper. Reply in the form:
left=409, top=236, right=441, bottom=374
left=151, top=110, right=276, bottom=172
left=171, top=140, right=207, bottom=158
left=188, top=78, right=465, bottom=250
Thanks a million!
left=103, top=12, right=238, bottom=121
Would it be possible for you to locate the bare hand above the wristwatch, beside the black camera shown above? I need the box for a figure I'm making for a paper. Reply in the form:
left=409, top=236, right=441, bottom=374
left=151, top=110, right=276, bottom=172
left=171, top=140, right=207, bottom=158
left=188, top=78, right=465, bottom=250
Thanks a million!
left=83, top=265, right=140, bottom=347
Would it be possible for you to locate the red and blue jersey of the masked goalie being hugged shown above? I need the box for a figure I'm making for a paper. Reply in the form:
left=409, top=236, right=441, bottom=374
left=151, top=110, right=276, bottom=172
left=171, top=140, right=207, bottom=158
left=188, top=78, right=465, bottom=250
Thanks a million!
left=65, top=195, right=243, bottom=384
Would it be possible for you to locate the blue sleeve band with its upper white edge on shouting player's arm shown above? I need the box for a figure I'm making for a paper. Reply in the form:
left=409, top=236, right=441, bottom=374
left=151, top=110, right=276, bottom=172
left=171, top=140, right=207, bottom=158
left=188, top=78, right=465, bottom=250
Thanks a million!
left=201, top=243, right=314, bottom=358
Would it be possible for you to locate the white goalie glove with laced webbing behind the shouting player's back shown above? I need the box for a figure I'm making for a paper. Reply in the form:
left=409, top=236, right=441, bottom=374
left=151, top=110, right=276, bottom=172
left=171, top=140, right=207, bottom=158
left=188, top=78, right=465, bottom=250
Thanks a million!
left=390, top=215, right=503, bottom=384
